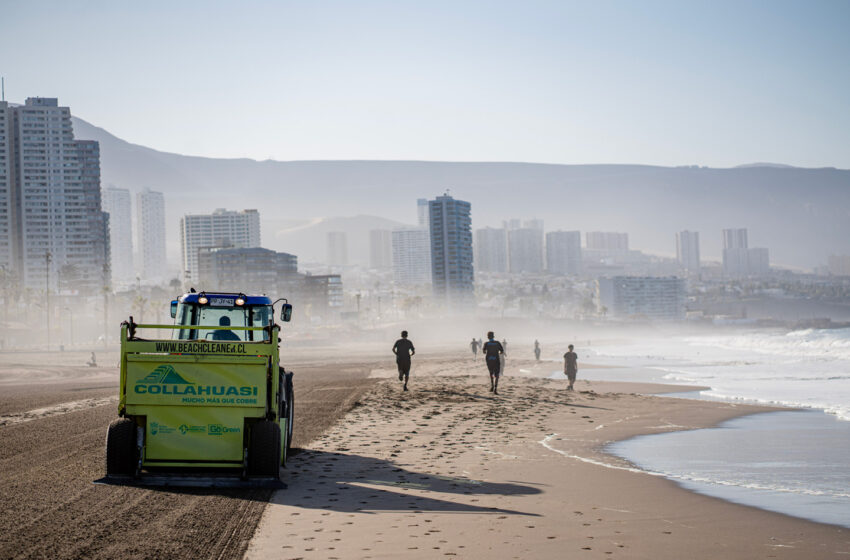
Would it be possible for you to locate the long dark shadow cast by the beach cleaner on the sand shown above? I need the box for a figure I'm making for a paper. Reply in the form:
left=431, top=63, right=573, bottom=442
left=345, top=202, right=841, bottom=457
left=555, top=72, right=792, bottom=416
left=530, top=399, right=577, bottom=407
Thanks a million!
left=271, top=450, right=542, bottom=517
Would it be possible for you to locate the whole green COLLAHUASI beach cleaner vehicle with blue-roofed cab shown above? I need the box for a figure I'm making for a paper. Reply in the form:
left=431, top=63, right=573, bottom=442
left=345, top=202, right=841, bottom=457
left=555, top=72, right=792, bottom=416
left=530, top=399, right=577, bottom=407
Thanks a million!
left=106, top=291, right=295, bottom=480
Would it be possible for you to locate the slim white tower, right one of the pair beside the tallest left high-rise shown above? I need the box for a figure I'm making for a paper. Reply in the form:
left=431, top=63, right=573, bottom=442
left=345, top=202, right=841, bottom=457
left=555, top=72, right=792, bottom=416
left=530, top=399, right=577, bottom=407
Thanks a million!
left=136, top=189, right=166, bottom=282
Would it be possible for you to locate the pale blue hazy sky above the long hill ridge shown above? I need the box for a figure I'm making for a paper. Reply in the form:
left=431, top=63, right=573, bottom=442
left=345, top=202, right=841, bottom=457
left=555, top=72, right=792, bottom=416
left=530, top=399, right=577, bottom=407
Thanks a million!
left=0, top=0, right=850, bottom=168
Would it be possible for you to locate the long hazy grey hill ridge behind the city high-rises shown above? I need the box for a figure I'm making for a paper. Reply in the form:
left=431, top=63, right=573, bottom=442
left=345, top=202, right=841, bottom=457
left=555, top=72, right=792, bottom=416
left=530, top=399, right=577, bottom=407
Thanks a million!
left=74, top=118, right=850, bottom=267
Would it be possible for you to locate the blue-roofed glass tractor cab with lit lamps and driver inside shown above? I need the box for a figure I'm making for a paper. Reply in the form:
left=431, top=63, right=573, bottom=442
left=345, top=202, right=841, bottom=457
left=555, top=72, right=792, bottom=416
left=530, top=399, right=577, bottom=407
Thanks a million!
left=171, top=292, right=292, bottom=342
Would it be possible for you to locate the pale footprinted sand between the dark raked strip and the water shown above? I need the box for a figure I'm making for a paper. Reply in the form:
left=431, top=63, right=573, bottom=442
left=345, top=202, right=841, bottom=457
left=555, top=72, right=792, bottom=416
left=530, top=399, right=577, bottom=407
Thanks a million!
left=246, top=355, right=850, bottom=560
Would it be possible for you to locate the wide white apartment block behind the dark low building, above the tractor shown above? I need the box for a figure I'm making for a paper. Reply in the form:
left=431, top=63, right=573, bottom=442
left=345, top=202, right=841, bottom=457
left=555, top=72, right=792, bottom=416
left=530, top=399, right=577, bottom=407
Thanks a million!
left=180, top=208, right=260, bottom=282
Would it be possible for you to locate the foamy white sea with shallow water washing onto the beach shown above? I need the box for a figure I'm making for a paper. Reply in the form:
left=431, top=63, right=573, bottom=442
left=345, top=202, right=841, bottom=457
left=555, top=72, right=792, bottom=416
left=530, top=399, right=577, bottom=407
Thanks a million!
left=551, top=329, right=850, bottom=527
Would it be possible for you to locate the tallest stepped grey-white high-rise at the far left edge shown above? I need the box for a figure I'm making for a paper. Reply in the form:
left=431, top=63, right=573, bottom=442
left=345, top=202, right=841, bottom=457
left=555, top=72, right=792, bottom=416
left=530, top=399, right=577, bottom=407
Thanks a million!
left=0, top=97, right=109, bottom=293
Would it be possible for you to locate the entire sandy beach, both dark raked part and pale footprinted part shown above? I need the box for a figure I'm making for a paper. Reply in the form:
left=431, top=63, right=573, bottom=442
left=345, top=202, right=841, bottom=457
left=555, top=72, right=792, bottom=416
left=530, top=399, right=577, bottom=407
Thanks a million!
left=0, top=348, right=850, bottom=559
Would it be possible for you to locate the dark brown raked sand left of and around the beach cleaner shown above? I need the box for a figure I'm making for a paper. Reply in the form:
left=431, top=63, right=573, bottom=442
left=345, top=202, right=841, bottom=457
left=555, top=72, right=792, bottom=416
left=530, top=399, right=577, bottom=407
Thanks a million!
left=0, top=351, right=377, bottom=559
